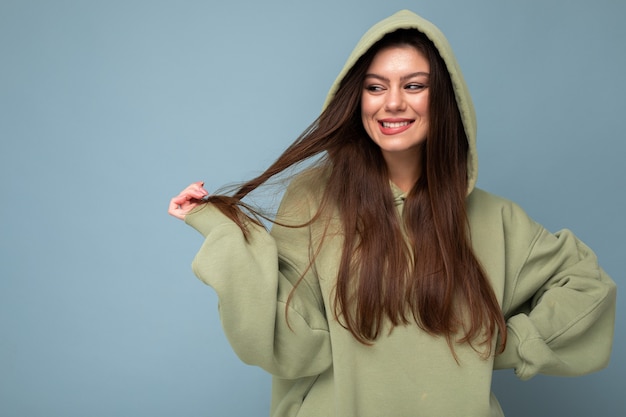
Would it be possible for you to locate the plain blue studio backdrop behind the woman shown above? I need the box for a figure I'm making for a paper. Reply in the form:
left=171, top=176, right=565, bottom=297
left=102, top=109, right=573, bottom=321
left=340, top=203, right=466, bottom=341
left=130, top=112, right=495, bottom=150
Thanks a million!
left=0, top=0, right=626, bottom=417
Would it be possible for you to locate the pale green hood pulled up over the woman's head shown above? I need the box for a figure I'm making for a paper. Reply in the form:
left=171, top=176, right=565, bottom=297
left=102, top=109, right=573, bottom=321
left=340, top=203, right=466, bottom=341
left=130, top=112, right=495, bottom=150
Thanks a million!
left=324, top=10, right=478, bottom=194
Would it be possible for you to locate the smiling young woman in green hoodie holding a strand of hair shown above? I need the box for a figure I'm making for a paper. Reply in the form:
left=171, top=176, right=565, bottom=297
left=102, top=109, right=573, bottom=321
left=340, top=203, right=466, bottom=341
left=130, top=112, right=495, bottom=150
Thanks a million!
left=169, top=11, right=615, bottom=417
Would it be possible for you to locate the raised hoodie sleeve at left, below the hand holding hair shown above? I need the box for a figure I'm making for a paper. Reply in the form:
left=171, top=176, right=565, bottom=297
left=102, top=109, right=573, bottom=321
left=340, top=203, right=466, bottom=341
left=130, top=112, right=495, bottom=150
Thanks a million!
left=185, top=180, right=331, bottom=379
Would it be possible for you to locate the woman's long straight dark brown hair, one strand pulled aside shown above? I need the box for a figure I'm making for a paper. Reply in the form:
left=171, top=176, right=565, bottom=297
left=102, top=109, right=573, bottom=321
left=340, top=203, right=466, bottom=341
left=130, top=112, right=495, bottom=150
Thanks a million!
left=209, top=29, right=506, bottom=354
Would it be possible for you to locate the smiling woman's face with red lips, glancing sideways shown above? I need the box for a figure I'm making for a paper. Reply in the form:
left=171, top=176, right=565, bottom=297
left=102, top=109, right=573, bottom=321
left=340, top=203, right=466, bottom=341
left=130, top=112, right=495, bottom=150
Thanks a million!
left=361, top=45, right=430, bottom=163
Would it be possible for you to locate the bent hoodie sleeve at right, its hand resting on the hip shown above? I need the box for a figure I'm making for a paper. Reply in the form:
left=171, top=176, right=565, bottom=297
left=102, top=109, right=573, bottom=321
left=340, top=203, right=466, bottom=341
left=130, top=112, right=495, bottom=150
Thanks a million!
left=495, top=205, right=616, bottom=380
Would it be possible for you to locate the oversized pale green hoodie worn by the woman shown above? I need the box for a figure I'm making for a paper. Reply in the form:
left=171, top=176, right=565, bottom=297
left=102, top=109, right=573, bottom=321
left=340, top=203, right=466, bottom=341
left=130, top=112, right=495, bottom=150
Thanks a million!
left=185, top=11, right=616, bottom=417
